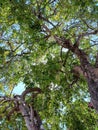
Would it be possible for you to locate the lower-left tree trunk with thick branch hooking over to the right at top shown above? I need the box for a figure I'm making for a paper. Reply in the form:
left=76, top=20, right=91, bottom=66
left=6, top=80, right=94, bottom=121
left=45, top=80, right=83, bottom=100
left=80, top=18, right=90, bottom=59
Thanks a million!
left=19, top=88, right=44, bottom=130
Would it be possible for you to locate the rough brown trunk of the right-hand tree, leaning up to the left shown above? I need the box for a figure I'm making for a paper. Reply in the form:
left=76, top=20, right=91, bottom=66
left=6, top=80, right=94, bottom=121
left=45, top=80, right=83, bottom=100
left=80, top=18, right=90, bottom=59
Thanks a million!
left=54, top=35, right=98, bottom=111
